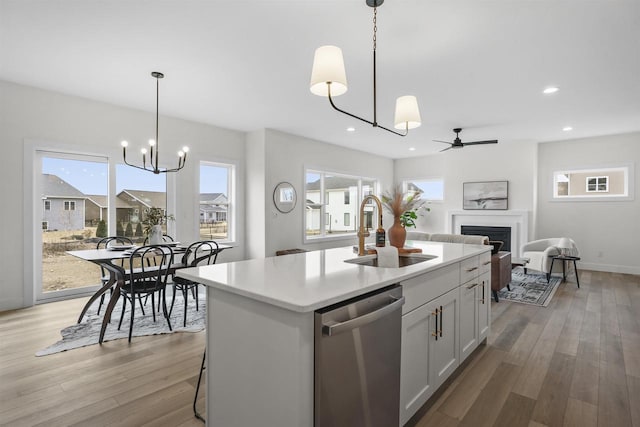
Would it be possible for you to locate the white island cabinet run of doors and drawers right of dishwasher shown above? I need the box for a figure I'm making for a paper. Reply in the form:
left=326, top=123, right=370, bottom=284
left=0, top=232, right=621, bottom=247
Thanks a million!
left=400, top=252, right=491, bottom=425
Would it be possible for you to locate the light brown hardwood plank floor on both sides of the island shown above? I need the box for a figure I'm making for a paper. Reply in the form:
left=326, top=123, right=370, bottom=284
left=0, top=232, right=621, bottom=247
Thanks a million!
left=0, top=271, right=640, bottom=427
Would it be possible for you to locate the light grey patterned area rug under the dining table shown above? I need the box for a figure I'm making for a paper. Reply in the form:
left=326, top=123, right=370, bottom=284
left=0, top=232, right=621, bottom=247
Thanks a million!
left=36, top=292, right=206, bottom=356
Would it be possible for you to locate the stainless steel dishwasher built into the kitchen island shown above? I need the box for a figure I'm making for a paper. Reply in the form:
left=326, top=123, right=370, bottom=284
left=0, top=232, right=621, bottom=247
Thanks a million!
left=314, top=285, right=404, bottom=427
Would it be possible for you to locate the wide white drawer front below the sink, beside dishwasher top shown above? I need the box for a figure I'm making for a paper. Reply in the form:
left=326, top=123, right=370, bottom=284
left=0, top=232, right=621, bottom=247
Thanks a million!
left=400, top=264, right=460, bottom=314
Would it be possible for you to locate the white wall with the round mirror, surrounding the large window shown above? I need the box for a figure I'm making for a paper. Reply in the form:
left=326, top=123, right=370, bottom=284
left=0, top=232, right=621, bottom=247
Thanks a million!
left=263, top=130, right=393, bottom=256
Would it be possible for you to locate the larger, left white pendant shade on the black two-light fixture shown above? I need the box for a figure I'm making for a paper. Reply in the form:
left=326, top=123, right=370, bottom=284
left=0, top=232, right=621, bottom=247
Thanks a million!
left=309, top=46, right=347, bottom=97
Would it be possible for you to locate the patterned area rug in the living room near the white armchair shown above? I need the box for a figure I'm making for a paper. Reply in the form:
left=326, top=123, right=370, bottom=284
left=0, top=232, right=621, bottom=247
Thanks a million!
left=498, top=268, right=562, bottom=307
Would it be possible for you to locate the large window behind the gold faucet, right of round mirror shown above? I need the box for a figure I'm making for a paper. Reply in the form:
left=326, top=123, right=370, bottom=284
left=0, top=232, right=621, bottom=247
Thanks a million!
left=304, top=170, right=377, bottom=239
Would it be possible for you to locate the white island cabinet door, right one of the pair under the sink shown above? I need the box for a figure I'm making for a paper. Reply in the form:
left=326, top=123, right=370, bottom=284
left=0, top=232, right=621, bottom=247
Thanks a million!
left=427, top=288, right=460, bottom=388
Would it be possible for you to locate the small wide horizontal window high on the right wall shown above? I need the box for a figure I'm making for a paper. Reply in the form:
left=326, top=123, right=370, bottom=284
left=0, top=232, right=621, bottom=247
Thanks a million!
left=553, top=166, right=633, bottom=200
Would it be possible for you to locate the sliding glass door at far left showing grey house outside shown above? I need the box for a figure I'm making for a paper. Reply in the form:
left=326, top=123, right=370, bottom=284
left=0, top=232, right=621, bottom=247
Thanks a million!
left=35, top=151, right=109, bottom=300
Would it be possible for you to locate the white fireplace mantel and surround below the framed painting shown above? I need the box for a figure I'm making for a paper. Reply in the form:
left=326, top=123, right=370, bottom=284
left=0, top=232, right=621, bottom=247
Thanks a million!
left=448, top=210, right=529, bottom=257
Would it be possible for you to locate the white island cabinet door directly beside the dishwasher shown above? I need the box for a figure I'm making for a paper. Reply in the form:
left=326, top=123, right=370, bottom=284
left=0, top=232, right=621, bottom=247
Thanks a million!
left=400, top=304, right=435, bottom=425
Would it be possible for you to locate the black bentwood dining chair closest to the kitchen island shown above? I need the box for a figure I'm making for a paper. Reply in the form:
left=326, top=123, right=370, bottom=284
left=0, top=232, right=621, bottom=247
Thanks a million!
left=169, top=240, right=220, bottom=327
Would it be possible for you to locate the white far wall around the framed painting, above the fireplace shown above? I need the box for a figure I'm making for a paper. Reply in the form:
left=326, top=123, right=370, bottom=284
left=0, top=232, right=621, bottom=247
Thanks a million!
left=394, top=143, right=536, bottom=236
